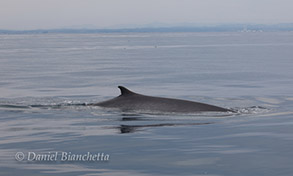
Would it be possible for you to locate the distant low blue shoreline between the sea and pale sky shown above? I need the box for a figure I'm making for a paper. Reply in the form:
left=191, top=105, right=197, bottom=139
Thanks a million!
left=0, top=23, right=293, bottom=34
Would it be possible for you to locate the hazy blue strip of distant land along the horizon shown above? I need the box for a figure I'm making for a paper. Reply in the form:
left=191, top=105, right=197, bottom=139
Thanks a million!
left=0, top=23, right=293, bottom=33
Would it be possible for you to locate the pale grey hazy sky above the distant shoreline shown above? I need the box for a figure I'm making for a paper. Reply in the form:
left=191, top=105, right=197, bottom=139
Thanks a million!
left=0, top=0, right=293, bottom=29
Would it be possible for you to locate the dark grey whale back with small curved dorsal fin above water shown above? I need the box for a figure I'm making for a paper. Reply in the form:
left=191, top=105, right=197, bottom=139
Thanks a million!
left=90, top=86, right=232, bottom=113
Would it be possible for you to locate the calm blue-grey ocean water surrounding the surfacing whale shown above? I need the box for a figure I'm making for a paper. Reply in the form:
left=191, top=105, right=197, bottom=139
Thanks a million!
left=0, top=32, right=293, bottom=176
